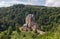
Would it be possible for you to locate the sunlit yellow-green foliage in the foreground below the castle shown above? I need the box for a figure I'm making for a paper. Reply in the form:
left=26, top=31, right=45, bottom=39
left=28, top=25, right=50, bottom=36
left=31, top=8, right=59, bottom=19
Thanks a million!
left=0, top=25, right=60, bottom=39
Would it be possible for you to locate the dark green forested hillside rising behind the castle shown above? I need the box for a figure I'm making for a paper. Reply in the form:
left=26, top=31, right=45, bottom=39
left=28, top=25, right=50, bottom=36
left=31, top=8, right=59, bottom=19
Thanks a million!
left=0, top=4, right=60, bottom=32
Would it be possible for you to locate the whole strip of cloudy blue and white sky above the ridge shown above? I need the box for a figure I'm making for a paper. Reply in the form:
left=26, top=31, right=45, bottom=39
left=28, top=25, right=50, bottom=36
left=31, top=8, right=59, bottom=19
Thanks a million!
left=0, top=0, right=60, bottom=7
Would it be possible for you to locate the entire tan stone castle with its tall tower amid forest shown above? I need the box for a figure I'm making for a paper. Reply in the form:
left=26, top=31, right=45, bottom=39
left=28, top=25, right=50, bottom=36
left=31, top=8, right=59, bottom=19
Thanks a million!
left=21, top=14, right=45, bottom=34
